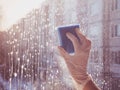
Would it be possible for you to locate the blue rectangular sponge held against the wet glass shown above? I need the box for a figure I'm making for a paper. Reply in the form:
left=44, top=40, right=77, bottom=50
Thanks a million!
left=57, top=24, right=80, bottom=53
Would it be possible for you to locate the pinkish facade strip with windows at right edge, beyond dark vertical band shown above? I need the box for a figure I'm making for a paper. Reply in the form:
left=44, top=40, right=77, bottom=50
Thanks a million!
left=108, top=0, right=120, bottom=90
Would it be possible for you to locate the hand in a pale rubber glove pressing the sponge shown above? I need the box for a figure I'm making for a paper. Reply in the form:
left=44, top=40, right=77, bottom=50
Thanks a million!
left=58, top=28, right=91, bottom=88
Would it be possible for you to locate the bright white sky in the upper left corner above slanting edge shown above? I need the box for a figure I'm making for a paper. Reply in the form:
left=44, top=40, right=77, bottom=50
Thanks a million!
left=0, top=0, right=45, bottom=29
